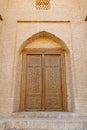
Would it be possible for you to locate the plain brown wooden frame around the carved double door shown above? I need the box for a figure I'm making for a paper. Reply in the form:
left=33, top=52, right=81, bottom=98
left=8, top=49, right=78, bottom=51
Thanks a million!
left=19, top=48, right=67, bottom=111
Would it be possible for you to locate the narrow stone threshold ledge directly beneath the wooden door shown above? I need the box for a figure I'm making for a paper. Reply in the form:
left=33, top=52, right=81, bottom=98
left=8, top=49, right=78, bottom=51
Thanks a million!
left=11, top=111, right=82, bottom=119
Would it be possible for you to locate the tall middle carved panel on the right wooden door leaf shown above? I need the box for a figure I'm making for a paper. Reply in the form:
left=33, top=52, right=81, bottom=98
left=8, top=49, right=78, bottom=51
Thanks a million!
left=45, top=67, right=61, bottom=94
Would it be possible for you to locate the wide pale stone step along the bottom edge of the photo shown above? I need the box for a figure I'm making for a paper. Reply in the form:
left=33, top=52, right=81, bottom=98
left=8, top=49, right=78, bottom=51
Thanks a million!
left=0, top=118, right=87, bottom=130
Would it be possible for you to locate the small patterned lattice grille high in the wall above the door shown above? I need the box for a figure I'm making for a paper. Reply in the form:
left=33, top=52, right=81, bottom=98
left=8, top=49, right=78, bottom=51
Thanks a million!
left=36, top=0, right=50, bottom=10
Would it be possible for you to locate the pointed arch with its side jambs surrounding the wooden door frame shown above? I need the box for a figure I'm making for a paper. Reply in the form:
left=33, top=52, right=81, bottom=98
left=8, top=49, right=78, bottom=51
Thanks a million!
left=15, top=31, right=72, bottom=111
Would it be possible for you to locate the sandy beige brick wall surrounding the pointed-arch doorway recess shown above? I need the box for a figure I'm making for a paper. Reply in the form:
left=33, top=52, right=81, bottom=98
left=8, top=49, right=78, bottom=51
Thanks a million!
left=0, top=0, right=87, bottom=115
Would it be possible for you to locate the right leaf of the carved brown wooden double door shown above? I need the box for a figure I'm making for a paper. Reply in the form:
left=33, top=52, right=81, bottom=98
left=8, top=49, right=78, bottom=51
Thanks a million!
left=45, top=55, right=62, bottom=110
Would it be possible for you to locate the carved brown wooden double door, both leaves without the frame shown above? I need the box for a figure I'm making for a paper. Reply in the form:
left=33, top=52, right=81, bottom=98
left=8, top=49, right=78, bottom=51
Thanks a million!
left=25, top=54, right=63, bottom=110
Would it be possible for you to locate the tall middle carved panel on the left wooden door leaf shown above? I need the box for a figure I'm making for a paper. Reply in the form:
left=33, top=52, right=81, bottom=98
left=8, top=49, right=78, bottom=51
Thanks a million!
left=26, top=67, right=42, bottom=95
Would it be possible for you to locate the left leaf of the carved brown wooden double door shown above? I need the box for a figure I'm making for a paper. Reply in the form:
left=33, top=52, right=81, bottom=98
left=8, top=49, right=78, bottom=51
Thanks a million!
left=25, top=55, right=42, bottom=110
